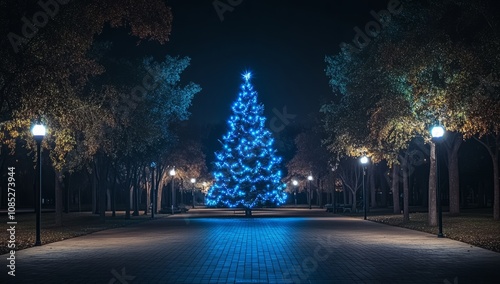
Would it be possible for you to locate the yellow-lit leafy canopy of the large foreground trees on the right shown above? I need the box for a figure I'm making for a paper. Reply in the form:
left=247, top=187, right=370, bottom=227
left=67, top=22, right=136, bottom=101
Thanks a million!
left=322, top=0, right=499, bottom=220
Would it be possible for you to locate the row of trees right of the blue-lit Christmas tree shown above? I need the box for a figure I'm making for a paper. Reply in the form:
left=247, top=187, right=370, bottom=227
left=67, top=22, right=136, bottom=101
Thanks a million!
left=288, top=0, right=500, bottom=222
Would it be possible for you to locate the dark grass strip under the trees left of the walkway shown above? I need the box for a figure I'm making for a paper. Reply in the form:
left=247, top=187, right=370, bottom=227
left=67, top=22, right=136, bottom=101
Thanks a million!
left=0, top=212, right=165, bottom=254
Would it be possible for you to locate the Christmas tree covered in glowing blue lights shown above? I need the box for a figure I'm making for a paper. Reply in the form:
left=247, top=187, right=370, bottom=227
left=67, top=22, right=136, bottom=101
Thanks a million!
left=207, top=73, right=286, bottom=209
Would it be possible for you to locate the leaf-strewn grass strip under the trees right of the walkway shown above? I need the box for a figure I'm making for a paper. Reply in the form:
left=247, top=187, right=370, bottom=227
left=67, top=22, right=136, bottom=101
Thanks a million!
left=348, top=206, right=500, bottom=252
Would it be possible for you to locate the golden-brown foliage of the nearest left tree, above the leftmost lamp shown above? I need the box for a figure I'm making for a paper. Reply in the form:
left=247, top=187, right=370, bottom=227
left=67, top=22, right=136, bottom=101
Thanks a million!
left=0, top=1, right=172, bottom=172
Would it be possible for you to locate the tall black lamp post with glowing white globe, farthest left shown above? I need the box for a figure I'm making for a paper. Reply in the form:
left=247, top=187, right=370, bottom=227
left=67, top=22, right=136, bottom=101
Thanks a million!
left=31, top=124, right=45, bottom=246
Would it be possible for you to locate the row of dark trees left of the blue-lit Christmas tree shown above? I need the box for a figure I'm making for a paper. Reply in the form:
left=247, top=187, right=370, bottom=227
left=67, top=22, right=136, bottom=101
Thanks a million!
left=0, top=0, right=206, bottom=225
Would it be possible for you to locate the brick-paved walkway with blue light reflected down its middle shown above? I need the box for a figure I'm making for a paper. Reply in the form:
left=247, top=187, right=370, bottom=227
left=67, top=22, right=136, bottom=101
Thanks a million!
left=0, top=209, right=500, bottom=284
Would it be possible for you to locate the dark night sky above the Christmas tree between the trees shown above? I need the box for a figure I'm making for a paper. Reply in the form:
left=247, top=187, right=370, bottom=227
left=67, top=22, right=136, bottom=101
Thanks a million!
left=159, top=0, right=389, bottom=124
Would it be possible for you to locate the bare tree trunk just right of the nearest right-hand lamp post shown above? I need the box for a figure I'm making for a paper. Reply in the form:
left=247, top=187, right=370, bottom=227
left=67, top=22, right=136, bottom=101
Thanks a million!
left=447, top=133, right=463, bottom=215
